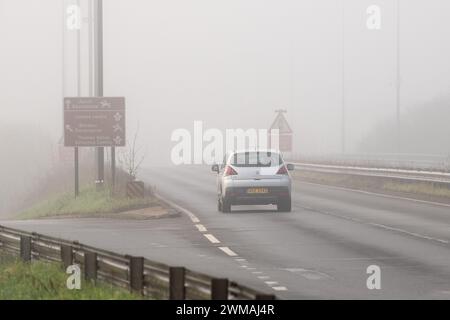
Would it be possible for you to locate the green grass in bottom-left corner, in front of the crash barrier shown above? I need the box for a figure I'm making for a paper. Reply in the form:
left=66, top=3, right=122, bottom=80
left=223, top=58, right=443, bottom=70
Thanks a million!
left=0, top=254, right=142, bottom=300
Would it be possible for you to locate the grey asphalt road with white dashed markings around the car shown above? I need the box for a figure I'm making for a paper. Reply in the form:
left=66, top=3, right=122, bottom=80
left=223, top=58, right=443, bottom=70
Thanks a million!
left=2, top=166, right=450, bottom=299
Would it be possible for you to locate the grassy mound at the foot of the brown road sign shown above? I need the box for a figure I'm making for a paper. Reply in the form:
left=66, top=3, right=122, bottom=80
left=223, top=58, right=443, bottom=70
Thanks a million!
left=17, top=185, right=157, bottom=219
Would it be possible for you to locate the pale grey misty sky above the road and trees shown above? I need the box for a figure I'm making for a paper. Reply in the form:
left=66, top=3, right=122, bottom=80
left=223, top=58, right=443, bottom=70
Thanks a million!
left=0, top=0, right=450, bottom=161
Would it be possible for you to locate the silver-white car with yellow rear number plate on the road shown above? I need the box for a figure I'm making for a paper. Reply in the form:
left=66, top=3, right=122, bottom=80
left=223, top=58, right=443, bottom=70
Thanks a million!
left=211, top=150, right=294, bottom=212
